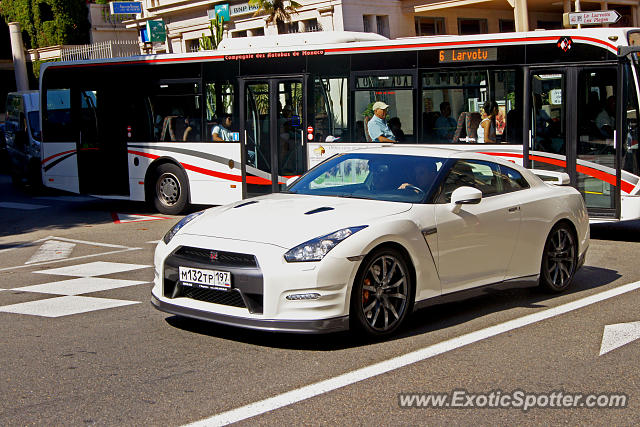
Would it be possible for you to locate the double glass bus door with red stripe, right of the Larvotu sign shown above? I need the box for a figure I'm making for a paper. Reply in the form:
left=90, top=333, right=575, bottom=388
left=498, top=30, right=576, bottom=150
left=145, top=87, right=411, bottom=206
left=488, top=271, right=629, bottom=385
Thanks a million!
left=525, top=65, right=620, bottom=217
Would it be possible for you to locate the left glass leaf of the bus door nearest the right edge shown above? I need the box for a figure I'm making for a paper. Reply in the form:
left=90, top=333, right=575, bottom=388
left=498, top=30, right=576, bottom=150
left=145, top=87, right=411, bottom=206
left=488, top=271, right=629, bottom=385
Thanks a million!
left=530, top=71, right=567, bottom=172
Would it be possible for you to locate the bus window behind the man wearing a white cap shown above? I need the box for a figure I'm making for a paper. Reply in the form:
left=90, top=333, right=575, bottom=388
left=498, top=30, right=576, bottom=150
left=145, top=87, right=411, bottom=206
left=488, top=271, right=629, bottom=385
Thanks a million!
left=354, top=75, right=415, bottom=143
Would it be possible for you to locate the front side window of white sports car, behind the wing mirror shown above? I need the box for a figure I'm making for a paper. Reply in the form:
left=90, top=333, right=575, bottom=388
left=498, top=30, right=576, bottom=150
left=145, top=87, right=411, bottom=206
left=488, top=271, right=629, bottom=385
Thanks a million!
left=437, top=160, right=503, bottom=203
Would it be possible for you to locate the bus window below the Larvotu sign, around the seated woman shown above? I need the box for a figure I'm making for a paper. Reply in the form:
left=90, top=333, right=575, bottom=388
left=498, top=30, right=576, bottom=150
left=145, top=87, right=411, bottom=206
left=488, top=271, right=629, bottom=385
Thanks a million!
left=419, top=69, right=522, bottom=144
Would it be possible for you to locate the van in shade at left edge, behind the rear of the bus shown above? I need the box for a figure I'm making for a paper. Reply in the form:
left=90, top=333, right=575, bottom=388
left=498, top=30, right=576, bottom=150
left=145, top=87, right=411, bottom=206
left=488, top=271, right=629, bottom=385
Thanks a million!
left=4, top=90, right=42, bottom=187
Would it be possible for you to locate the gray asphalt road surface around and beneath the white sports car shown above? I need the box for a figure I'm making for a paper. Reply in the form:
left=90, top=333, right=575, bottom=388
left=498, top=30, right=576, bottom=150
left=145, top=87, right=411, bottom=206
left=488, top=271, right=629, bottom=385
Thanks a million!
left=0, top=176, right=640, bottom=425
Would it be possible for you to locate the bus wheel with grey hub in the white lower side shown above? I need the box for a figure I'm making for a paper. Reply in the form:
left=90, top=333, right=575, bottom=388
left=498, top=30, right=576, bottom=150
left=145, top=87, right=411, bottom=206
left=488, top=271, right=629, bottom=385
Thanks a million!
left=153, top=163, right=189, bottom=215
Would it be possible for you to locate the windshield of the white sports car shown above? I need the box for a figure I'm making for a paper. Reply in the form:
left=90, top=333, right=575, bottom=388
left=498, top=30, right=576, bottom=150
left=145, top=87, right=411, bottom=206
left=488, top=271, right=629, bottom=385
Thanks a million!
left=287, top=153, right=445, bottom=203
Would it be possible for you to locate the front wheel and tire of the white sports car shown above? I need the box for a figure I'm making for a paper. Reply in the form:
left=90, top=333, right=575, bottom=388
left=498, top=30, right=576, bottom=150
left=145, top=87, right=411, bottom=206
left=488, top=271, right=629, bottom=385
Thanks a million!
left=349, top=248, right=414, bottom=337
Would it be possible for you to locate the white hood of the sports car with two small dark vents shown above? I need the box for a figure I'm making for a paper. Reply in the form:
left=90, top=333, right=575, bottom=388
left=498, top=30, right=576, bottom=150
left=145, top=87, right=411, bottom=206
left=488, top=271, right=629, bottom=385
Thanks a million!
left=182, top=194, right=412, bottom=249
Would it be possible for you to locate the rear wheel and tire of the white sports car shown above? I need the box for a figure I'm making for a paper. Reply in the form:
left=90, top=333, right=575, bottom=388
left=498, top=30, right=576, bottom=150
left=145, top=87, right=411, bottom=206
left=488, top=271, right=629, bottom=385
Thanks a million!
left=540, top=223, right=578, bottom=292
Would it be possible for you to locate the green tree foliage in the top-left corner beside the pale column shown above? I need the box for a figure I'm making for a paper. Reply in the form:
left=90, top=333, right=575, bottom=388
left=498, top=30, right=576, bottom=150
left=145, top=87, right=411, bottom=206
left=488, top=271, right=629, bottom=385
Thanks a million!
left=0, top=0, right=91, bottom=49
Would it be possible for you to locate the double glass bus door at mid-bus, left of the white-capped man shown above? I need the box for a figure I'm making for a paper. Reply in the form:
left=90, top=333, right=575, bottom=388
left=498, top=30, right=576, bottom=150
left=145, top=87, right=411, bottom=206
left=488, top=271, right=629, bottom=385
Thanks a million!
left=239, top=76, right=306, bottom=197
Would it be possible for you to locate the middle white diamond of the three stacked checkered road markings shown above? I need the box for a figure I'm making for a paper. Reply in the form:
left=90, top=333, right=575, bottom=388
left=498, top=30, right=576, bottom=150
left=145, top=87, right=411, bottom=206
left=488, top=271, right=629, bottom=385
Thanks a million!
left=12, top=277, right=149, bottom=295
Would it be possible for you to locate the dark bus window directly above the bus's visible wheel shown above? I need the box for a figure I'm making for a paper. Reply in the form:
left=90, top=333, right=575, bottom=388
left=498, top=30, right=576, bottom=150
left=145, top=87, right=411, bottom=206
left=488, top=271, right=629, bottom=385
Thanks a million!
left=149, top=82, right=202, bottom=142
